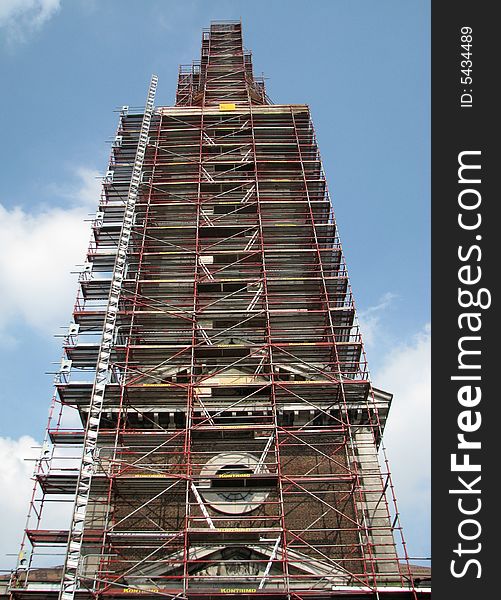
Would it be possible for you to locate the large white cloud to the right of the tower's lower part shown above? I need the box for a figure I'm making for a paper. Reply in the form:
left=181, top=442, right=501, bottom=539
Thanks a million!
left=373, top=325, right=431, bottom=548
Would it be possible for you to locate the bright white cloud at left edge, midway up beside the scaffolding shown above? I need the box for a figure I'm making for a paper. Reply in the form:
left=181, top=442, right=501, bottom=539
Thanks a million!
left=0, top=169, right=100, bottom=342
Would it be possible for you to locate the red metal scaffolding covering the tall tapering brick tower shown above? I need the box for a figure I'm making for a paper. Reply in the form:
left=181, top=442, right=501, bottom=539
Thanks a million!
left=10, top=22, right=429, bottom=600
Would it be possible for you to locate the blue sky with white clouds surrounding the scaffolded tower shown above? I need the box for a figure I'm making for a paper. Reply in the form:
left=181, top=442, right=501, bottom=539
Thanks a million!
left=0, top=0, right=430, bottom=568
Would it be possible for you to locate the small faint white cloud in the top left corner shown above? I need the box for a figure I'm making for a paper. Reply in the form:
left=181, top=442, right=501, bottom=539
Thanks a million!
left=0, top=0, right=61, bottom=42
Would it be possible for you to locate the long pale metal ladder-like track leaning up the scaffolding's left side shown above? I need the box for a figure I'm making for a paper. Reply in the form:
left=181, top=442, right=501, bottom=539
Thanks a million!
left=59, top=75, right=158, bottom=600
